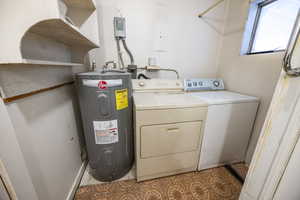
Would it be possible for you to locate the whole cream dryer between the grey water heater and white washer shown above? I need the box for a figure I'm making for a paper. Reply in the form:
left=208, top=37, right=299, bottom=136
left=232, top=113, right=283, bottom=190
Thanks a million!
left=132, top=79, right=207, bottom=181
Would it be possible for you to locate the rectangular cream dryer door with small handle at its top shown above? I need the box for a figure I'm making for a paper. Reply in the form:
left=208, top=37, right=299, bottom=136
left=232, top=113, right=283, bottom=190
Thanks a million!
left=141, top=121, right=202, bottom=158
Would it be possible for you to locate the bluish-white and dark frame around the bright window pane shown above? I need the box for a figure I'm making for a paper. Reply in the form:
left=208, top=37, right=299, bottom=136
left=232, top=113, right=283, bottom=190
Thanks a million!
left=241, top=0, right=292, bottom=55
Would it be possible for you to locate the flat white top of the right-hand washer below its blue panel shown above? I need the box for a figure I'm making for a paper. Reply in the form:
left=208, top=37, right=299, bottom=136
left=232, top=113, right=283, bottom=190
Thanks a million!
left=188, top=91, right=259, bottom=105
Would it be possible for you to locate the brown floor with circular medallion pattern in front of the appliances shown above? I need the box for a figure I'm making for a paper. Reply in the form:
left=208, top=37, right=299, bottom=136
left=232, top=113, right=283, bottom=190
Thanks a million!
left=75, top=167, right=242, bottom=200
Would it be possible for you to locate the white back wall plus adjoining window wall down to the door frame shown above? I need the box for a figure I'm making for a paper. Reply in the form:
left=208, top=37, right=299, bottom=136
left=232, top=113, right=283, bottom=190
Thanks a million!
left=94, top=0, right=283, bottom=162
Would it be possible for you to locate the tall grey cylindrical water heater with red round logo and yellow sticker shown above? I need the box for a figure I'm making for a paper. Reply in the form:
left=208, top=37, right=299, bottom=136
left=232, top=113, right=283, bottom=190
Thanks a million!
left=76, top=72, right=134, bottom=181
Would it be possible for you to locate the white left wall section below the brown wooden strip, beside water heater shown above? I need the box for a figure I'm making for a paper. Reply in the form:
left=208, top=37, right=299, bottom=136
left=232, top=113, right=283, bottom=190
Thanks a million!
left=6, top=86, right=82, bottom=200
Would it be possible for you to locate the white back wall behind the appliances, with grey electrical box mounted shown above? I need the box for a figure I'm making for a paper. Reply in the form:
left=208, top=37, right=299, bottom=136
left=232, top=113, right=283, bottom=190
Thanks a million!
left=91, top=0, right=225, bottom=77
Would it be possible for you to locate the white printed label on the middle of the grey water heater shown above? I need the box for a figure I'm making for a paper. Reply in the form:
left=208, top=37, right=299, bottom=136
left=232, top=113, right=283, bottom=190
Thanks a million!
left=93, top=120, right=119, bottom=144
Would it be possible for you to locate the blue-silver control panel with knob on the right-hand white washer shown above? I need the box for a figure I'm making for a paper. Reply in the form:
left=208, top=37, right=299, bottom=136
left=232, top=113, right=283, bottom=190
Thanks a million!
left=184, top=79, right=225, bottom=91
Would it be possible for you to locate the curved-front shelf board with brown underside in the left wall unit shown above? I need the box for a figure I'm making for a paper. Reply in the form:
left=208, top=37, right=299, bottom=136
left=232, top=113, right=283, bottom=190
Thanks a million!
left=29, top=19, right=99, bottom=49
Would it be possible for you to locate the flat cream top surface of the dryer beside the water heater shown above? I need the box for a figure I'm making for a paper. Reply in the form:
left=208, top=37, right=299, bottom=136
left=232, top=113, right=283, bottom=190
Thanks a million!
left=133, top=93, right=207, bottom=110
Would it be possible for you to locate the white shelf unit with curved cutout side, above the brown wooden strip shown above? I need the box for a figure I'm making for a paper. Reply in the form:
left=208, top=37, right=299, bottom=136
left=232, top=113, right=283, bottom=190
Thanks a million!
left=0, top=0, right=99, bottom=66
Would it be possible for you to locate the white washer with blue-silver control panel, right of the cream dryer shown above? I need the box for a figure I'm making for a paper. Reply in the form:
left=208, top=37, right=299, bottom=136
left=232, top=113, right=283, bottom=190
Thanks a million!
left=184, top=79, right=259, bottom=170
